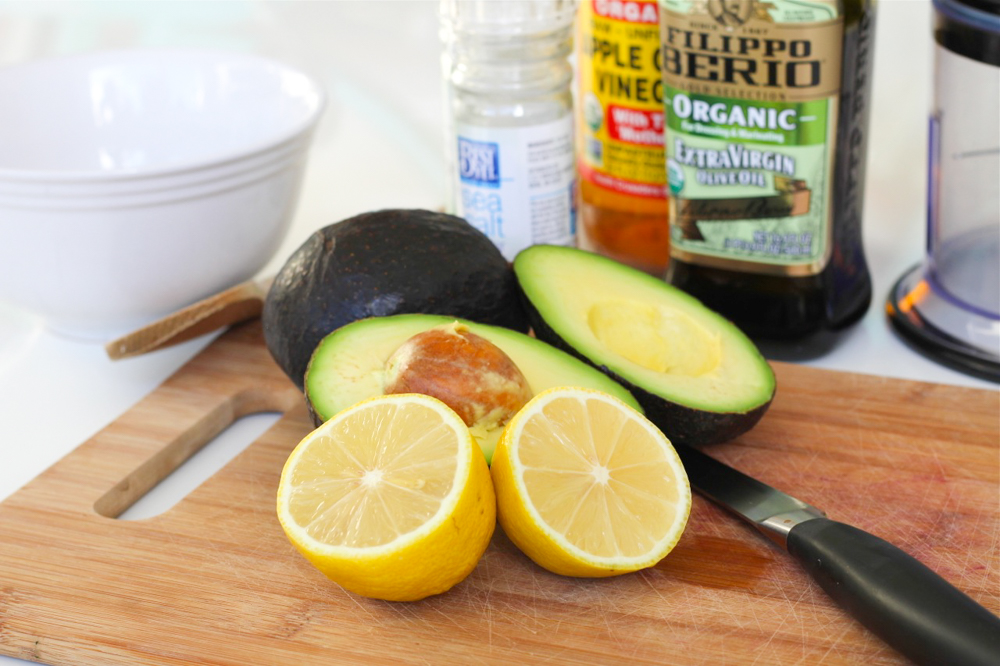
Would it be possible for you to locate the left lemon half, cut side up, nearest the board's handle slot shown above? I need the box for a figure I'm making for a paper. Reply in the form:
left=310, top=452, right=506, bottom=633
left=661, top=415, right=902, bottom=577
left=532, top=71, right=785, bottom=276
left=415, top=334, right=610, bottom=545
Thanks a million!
left=278, top=393, right=496, bottom=601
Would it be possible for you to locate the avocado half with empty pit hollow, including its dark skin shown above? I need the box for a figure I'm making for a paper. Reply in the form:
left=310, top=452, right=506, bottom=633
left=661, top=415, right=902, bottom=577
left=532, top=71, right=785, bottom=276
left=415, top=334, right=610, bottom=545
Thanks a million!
left=514, top=245, right=775, bottom=445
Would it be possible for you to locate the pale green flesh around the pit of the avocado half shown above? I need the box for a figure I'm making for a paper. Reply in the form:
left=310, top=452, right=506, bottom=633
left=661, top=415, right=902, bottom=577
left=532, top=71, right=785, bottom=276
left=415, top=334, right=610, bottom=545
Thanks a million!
left=305, top=314, right=642, bottom=462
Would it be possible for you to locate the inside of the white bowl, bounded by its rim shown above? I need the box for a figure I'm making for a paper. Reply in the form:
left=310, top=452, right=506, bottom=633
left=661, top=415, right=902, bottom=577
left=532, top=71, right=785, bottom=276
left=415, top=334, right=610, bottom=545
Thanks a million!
left=0, top=49, right=323, bottom=181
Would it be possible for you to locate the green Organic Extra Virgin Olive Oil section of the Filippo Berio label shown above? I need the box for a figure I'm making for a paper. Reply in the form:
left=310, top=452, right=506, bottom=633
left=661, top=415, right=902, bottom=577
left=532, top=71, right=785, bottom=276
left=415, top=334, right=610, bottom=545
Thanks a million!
left=666, top=86, right=830, bottom=265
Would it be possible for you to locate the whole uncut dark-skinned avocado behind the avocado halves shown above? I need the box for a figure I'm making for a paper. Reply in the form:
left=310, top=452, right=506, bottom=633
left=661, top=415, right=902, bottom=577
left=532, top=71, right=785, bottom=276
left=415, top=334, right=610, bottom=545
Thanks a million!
left=262, top=210, right=528, bottom=389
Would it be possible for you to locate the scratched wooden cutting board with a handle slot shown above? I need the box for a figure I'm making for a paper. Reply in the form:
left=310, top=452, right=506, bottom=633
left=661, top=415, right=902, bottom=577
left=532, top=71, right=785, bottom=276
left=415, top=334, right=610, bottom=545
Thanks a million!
left=0, top=323, right=1000, bottom=666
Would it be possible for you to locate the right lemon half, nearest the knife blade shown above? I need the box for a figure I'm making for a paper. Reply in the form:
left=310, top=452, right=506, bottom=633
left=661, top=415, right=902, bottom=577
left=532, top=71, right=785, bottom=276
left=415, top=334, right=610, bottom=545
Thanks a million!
left=491, top=387, right=691, bottom=577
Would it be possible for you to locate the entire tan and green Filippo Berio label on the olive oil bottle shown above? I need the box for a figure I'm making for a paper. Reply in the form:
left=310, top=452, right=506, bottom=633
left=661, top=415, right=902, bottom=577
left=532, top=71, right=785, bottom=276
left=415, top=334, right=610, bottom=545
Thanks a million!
left=660, top=0, right=843, bottom=275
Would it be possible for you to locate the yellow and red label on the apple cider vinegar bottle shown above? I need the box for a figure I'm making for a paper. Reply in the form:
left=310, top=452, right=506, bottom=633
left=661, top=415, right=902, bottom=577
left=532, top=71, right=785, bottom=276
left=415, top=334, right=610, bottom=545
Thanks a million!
left=577, top=0, right=666, bottom=200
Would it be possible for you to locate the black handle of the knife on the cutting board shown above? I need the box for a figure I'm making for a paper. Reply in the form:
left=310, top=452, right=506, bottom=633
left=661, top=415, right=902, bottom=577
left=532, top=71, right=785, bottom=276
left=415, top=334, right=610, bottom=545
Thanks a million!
left=787, top=518, right=1000, bottom=666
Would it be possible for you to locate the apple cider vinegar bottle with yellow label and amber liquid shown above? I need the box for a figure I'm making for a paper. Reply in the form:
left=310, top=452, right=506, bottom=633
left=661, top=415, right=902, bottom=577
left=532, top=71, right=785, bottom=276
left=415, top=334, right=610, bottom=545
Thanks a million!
left=576, top=0, right=669, bottom=276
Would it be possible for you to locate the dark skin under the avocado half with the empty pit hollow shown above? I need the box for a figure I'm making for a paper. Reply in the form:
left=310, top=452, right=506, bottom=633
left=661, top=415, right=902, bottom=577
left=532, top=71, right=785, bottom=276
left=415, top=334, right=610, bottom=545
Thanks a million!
left=522, top=294, right=774, bottom=446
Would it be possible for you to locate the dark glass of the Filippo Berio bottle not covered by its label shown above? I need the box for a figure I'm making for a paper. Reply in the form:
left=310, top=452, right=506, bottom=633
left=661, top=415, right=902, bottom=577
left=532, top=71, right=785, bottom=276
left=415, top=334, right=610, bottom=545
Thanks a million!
left=666, top=0, right=875, bottom=360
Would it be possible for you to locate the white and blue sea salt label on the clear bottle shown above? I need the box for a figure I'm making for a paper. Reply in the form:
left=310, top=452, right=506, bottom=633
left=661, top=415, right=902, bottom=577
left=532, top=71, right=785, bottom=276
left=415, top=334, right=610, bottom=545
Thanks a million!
left=455, top=114, right=576, bottom=260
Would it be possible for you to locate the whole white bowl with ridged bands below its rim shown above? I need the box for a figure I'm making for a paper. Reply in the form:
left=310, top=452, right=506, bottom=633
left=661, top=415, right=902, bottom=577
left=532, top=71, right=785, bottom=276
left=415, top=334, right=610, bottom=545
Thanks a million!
left=0, top=49, right=325, bottom=340
